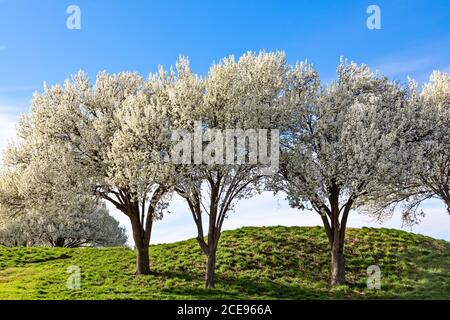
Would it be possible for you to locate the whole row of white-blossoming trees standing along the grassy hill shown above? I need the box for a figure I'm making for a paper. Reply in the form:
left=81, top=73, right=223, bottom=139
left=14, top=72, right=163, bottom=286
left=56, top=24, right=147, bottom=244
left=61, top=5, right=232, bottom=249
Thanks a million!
left=0, top=52, right=450, bottom=287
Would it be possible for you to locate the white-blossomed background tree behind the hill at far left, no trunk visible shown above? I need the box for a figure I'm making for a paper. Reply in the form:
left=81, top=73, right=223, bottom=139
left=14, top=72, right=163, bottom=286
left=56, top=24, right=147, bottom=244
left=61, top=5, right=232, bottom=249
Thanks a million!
left=0, top=131, right=127, bottom=247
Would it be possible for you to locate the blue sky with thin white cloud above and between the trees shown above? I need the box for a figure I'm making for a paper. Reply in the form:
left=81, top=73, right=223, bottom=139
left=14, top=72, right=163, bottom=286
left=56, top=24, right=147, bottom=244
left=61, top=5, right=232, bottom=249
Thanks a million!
left=0, top=0, right=450, bottom=242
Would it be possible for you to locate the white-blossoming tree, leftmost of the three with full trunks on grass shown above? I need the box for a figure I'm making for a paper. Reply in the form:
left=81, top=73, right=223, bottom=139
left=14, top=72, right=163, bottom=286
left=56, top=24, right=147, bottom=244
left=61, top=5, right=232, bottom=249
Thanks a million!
left=4, top=69, right=176, bottom=275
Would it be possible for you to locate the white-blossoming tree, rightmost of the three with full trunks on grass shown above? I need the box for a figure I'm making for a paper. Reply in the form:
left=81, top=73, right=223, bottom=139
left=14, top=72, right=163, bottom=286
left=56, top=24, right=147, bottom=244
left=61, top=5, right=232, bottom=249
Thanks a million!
left=277, top=61, right=405, bottom=284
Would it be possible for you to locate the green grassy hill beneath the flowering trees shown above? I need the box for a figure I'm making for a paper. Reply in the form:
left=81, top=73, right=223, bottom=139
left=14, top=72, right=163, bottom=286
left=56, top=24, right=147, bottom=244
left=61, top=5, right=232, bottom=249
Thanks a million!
left=0, top=227, right=450, bottom=299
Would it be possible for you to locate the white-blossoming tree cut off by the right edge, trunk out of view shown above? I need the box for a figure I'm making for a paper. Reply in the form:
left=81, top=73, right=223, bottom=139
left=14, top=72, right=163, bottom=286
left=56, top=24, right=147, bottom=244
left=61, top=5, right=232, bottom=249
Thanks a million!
left=368, top=71, right=450, bottom=224
